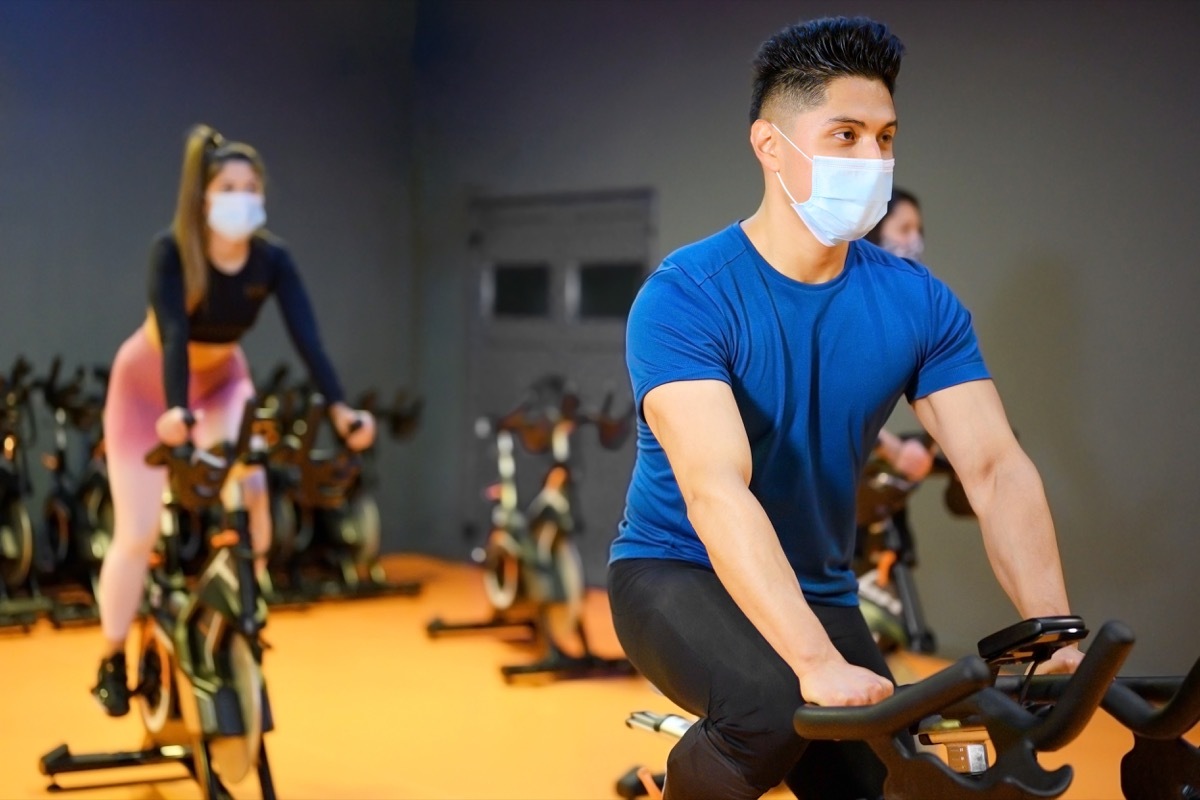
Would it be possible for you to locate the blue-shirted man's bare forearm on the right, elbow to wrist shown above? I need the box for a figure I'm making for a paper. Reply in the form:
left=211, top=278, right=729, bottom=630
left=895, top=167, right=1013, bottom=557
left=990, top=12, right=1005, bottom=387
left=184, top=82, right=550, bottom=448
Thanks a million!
left=966, top=447, right=1069, bottom=618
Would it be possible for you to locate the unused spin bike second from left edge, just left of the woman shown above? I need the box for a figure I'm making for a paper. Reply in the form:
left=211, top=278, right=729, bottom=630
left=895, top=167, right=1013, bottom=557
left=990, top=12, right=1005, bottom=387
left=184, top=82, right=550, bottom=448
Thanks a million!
left=35, top=357, right=113, bottom=627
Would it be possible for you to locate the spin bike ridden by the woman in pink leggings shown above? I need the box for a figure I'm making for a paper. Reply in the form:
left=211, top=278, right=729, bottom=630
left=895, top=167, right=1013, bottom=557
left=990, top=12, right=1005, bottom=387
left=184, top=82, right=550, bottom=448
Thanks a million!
left=40, top=401, right=275, bottom=800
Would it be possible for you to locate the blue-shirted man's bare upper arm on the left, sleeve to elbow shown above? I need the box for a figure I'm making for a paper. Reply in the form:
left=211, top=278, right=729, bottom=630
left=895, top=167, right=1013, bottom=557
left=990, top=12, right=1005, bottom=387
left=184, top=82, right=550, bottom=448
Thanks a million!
left=642, top=380, right=751, bottom=499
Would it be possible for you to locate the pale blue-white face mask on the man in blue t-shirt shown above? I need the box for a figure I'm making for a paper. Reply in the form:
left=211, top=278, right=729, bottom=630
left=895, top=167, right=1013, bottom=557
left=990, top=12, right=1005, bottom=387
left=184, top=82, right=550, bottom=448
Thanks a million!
left=770, top=122, right=896, bottom=247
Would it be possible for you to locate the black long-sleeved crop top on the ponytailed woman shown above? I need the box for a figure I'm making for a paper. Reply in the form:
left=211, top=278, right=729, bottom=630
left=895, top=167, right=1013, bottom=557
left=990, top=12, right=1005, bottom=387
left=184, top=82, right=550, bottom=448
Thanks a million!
left=150, top=233, right=344, bottom=408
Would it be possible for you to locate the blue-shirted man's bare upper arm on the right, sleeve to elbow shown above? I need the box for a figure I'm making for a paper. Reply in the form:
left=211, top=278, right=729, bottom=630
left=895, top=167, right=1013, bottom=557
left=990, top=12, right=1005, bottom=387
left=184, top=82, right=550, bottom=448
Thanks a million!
left=912, top=380, right=1015, bottom=480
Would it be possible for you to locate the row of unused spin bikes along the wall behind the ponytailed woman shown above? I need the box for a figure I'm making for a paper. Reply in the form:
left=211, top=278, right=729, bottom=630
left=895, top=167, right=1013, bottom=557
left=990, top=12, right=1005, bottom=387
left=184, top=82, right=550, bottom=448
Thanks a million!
left=0, top=359, right=421, bottom=630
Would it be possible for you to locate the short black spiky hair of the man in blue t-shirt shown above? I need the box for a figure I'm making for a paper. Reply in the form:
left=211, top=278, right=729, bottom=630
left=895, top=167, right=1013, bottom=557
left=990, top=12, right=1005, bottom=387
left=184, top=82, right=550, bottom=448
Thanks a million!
left=750, top=17, right=904, bottom=124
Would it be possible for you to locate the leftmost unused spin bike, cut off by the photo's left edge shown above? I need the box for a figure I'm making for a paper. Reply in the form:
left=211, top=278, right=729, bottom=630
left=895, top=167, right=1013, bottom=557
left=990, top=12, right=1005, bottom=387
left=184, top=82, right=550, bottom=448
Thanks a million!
left=0, top=359, right=50, bottom=631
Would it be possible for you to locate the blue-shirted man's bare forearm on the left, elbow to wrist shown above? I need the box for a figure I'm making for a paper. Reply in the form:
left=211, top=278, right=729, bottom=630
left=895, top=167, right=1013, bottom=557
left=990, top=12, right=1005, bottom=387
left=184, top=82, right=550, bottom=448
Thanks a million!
left=688, top=487, right=841, bottom=675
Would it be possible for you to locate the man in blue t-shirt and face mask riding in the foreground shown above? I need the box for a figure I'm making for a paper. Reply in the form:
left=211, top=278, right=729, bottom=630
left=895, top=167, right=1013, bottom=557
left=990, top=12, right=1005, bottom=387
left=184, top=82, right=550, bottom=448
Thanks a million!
left=608, top=18, right=1080, bottom=800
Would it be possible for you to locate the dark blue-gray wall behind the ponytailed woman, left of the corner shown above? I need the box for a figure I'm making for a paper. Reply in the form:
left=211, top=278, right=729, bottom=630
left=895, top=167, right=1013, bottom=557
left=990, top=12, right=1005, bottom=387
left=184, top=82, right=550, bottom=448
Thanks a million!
left=0, top=0, right=415, bottom=549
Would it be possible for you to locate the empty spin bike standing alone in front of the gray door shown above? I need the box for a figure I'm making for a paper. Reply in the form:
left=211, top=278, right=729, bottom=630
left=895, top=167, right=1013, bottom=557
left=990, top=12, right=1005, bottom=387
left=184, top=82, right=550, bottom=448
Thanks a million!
left=426, top=377, right=635, bottom=681
